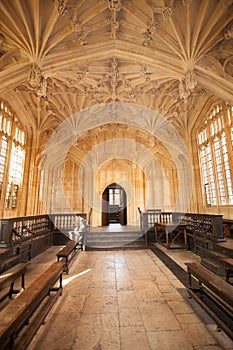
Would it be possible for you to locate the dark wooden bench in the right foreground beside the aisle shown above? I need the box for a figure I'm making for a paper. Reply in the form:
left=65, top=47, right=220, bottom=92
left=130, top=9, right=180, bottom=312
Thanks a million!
left=186, top=263, right=233, bottom=339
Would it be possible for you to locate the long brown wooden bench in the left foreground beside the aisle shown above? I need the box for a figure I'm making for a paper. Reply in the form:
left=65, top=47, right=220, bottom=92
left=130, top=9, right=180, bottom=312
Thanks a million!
left=0, top=262, right=63, bottom=350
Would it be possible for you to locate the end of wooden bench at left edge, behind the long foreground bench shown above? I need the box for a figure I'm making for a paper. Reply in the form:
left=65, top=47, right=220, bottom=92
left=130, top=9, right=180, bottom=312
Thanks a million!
left=0, top=263, right=28, bottom=302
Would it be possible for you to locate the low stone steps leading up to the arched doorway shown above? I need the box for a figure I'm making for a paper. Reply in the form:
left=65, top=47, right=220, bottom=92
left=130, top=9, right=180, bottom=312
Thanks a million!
left=85, top=230, right=147, bottom=250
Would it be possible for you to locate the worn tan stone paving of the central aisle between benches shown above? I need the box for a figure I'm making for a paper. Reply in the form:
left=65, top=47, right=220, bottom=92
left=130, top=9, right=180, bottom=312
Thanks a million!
left=26, top=249, right=233, bottom=350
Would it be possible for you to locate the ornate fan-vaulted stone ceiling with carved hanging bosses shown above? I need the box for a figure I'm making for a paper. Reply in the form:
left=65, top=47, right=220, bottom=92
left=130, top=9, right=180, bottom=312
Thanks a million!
left=0, top=0, right=233, bottom=137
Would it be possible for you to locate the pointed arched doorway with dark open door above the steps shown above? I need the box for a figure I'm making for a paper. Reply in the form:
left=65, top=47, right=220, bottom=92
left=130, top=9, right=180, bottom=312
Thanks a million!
left=102, top=183, right=127, bottom=226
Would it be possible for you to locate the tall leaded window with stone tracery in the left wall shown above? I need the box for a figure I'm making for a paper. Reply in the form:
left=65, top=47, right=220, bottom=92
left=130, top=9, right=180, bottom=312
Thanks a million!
left=0, top=101, right=25, bottom=209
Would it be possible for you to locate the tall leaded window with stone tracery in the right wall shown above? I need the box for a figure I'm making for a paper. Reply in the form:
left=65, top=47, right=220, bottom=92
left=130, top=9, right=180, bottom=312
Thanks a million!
left=198, top=104, right=233, bottom=205
